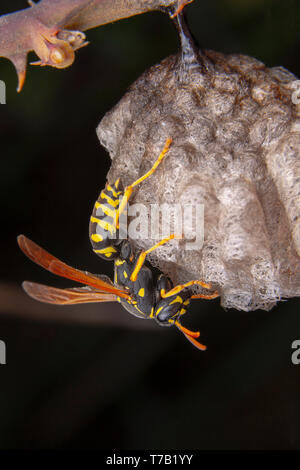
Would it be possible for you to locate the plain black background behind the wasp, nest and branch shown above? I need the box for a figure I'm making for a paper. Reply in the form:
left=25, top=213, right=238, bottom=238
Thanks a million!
left=0, top=0, right=300, bottom=449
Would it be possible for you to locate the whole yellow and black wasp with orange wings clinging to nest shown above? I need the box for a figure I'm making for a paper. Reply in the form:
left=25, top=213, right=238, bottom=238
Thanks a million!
left=18, top=139, right=218, bottom=350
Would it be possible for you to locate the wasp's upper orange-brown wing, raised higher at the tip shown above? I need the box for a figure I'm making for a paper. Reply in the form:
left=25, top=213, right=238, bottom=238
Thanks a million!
left=18, top=235, right=130, bottom=299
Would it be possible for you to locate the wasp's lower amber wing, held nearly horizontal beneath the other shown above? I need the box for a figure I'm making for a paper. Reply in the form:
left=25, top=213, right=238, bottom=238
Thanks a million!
left=22, top=281, right=117, bottom=305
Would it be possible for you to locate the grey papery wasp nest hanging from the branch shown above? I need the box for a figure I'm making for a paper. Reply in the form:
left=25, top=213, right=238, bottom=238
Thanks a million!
left=97, top=46, right=300, bottom=311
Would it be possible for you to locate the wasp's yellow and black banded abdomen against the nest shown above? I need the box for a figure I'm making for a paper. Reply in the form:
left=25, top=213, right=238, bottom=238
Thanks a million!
left=90, top=180, right=123, bottom=260
